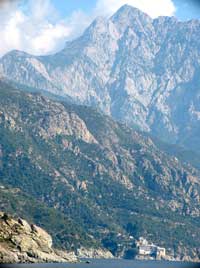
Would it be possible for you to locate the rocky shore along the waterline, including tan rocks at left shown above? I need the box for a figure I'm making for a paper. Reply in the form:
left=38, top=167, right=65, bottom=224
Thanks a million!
left=0, top=212, right=199, bottom=263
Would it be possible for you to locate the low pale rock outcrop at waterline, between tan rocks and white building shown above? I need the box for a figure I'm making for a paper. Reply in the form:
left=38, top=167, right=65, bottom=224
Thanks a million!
left=76, top=248, right=114, bottom=259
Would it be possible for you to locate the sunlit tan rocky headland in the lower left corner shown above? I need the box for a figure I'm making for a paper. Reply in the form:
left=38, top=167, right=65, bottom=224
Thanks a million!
left=0, top=212, right=76, bottom=263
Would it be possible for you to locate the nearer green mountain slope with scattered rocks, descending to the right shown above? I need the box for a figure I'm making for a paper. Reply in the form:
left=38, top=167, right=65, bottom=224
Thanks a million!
left=0, top=82, right=200, bottom=259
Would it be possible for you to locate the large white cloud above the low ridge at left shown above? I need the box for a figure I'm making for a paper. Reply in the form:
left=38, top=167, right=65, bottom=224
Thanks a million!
left=0, top=0, right=90, bottom=55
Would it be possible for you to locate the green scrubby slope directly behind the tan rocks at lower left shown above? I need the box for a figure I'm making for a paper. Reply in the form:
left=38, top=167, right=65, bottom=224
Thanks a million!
left=0, top=188, right=98, bottom=249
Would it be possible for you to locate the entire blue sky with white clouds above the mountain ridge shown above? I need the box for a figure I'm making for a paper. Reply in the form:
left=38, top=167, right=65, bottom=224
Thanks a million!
left=0, top=0, right=200, bottom=56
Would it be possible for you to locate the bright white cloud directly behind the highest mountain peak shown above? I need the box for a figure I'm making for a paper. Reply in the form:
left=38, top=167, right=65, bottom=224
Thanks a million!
left=96, top=0, right=176, bottom=18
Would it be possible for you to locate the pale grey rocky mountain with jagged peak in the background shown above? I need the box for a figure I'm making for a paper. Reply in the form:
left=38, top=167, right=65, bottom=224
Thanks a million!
left=0, top=5, right=200, bottom=152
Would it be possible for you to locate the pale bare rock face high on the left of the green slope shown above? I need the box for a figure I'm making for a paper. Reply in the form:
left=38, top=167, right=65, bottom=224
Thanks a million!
left=0, top=94, right=97, bottom=146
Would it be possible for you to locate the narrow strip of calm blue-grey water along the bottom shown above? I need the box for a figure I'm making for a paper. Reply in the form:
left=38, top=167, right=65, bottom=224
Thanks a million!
left=0, top=260, right=200, bottom=268
